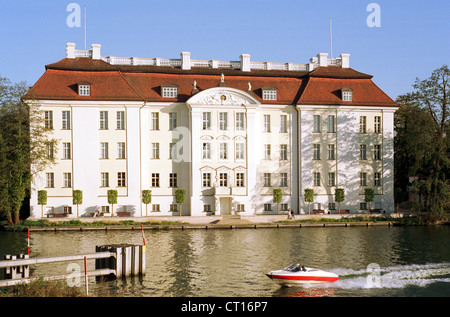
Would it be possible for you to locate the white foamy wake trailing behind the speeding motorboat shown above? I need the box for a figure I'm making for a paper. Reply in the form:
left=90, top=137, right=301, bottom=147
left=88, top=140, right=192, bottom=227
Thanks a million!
left=329, top=263, right=450, bottom=289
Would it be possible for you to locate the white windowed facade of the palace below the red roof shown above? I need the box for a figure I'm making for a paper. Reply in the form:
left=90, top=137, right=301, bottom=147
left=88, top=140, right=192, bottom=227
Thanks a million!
left=30, top=43, right=396, bottom=218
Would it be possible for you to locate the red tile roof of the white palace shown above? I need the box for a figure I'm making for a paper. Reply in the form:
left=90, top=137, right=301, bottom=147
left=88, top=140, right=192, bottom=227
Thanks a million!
left=25, top=58, right=396, bottom=106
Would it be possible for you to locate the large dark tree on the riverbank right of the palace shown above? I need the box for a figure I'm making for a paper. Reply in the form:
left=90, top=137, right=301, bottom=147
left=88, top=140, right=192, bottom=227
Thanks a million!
left=395, top=65, right=450, bottom=216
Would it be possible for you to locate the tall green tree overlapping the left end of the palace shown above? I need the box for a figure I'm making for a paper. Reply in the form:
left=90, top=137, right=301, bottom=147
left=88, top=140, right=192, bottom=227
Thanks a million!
left=0, top=77, right=56, bottom=224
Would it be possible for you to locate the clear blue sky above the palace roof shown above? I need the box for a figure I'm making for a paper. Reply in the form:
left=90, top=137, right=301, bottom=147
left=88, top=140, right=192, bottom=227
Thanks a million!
left=0, top=0, right=450, bottom=99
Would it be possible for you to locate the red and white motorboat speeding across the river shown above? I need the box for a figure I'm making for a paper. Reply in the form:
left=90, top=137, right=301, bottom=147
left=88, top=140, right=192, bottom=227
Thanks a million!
left=266, top=264, right=339, bottom=285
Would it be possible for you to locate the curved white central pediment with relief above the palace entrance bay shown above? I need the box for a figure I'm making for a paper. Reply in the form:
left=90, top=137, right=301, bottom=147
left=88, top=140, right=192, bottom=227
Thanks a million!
left=186, top=87, right=260, bottom=106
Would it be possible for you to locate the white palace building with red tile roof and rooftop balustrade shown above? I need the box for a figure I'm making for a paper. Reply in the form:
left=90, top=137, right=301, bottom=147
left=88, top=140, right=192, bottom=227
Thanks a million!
left=24, top=43, right=397, bottom=218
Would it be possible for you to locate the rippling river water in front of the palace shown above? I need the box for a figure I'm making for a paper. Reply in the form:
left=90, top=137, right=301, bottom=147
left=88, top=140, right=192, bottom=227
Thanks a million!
left=0, top=226, right=450, bottom=297
